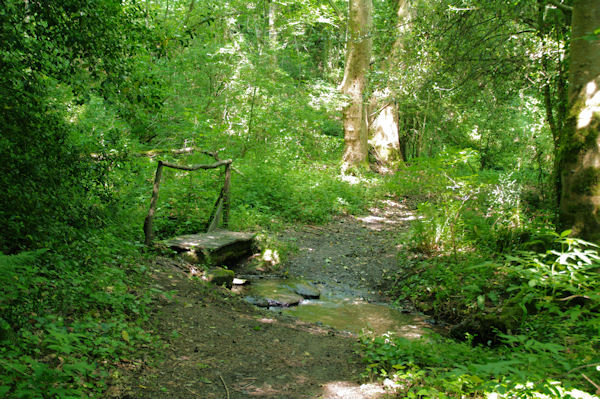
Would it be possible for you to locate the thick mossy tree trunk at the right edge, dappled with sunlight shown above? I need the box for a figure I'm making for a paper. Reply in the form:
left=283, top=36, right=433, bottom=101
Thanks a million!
left=560, top=0, right=600, bottom=241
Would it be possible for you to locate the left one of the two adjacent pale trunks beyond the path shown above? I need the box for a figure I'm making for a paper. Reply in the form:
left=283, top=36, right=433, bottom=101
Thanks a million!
left=340, top=0, right=373, bottom=167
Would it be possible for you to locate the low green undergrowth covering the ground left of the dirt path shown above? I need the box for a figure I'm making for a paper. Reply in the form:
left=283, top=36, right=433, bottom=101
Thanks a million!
left=0, top=234, right=157, bottom=398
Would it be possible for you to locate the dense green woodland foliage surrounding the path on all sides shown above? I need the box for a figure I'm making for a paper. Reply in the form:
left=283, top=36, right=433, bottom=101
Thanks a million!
left=0, top=0, right=600, bottom=397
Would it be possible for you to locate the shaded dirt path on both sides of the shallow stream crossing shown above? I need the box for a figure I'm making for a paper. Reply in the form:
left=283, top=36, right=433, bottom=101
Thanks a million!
left=117, top=201, right=412, bottom=399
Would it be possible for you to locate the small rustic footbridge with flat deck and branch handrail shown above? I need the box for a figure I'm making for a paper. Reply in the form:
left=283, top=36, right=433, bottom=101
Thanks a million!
left=144, top=151, right=255, bottom=263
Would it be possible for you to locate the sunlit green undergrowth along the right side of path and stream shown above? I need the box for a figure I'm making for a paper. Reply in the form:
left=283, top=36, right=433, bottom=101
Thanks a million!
left=361, top=151, right=600, bottom=398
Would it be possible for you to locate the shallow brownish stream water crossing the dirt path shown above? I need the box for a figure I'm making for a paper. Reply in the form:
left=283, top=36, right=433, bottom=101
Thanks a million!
left=245, top=279, right=427, bottom=338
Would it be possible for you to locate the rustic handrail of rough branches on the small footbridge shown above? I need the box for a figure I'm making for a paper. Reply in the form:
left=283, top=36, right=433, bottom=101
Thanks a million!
left=144, top=157, right=233, bottom=246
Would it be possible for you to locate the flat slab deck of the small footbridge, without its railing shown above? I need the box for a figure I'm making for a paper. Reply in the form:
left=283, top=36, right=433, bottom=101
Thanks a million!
left=162, top=230, right=255, bottom=264
